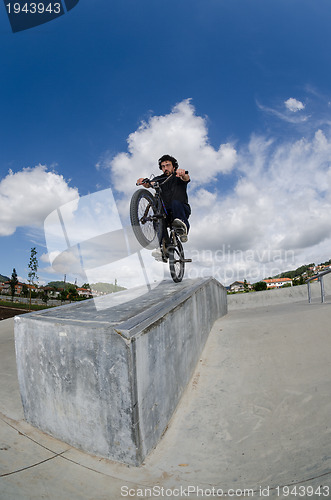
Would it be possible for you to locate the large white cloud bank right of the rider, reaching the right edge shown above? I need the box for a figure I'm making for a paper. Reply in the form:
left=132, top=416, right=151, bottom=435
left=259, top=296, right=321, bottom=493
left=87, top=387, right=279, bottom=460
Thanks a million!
left=190, top=130, right=331, bottom=282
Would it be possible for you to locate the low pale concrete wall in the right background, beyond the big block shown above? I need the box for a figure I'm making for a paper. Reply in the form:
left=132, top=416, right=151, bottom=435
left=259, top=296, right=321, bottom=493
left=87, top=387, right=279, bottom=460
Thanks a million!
left=228, top=273, right=331, bottom=311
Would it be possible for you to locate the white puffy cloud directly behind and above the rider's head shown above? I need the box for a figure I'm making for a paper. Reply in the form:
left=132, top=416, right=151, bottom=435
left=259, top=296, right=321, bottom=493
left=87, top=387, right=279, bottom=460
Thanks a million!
left=109, top=99, right=236, bottom=197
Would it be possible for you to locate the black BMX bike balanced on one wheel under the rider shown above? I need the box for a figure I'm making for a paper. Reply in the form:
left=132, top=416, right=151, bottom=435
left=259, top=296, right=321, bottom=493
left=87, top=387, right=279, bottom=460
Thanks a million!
left=130, top=172, right=192, bottom=283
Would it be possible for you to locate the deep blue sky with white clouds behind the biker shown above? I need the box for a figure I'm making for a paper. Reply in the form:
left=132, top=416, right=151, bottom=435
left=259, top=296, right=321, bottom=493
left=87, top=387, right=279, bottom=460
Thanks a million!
left=0, top=0, right=331, bottom=284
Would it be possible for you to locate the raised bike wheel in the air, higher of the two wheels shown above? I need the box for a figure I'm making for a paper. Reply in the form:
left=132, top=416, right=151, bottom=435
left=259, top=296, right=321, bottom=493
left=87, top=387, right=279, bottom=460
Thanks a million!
left=130, top=189, right=162, bottom=249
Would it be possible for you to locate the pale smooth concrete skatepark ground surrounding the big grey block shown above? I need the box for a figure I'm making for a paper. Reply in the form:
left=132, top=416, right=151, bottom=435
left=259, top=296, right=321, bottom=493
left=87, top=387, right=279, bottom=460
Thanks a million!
left=0, top=296, right=331, bottom=500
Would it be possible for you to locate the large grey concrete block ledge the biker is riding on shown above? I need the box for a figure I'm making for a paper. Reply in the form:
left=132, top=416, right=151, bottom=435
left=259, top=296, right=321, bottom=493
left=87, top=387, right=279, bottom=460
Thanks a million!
left=15, top=278, right=227, bottom=465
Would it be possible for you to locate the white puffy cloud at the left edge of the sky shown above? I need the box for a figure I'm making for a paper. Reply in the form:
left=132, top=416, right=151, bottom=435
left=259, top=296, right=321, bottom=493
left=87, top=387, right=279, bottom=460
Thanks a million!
left=0, top=165, right=78, bottom=236
